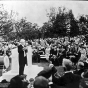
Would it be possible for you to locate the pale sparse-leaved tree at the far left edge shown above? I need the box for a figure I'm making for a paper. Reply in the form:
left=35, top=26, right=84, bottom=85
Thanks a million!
left=0, top=5, right=13, bottom=40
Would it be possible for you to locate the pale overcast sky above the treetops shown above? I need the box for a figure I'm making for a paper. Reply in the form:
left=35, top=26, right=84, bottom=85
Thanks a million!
left=0, top=0, right=88, bottom=26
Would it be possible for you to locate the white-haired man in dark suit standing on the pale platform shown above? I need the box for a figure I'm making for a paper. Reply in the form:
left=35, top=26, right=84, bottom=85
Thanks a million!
left=18, top=39, right=27, bottom=75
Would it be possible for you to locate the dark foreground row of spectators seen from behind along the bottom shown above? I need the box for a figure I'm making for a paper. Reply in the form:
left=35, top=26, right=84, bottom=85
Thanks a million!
left=2, top=61, right=88, bottom=88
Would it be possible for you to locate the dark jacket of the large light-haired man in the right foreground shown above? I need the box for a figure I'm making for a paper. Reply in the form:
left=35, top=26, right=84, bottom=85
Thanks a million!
left=53, top=72, right=81, bottom=88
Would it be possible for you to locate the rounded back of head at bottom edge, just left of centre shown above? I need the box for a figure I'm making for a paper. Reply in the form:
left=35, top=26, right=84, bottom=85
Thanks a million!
left=34, top=76, right=49, bottom=88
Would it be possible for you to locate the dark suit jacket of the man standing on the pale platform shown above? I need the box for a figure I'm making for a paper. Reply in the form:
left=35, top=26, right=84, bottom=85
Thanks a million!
left=18, top=45, right=27, bottom=66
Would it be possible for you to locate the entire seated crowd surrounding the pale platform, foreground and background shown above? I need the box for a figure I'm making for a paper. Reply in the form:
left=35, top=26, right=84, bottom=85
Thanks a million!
left=0, top=36, right=88, bottom=88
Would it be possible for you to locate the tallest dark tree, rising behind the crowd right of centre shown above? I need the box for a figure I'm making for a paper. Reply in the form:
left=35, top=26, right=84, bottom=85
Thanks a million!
left=43, top=7, right=79, bottom=36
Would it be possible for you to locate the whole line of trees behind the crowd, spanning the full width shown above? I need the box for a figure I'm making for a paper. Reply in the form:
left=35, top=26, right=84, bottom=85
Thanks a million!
left=0, top=5, right=88, bottom=41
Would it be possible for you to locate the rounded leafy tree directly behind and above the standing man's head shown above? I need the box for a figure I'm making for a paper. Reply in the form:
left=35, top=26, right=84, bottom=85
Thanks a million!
left=15, top=18, right=40, bottom=40
